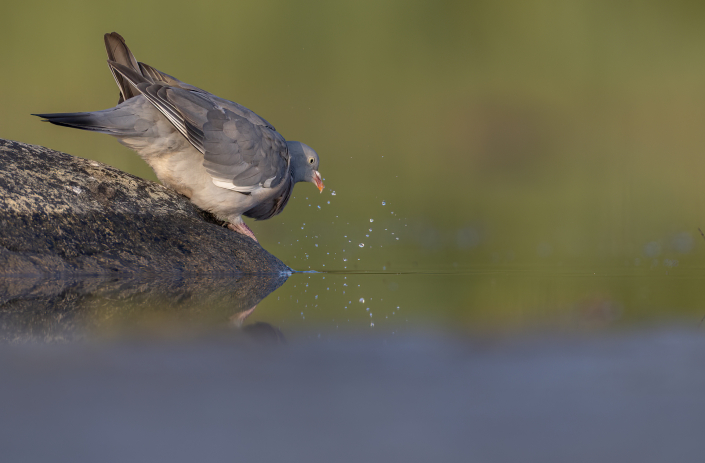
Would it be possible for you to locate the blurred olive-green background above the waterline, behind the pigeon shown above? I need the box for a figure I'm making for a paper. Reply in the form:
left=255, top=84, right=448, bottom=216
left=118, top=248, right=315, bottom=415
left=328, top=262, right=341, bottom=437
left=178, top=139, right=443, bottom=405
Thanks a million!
left=0, top=0, right=705, bottom=272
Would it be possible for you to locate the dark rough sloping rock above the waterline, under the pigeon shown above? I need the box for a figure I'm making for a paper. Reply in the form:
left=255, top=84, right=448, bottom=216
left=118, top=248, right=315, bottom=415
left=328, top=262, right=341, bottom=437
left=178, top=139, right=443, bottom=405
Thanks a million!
left=0, top=139, right=291, bottom=275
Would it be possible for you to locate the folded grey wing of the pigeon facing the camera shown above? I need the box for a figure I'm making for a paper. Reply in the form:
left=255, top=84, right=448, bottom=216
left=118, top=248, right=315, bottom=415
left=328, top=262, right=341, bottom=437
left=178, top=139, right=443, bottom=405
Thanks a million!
left=108, top=61, right=291, bottom=194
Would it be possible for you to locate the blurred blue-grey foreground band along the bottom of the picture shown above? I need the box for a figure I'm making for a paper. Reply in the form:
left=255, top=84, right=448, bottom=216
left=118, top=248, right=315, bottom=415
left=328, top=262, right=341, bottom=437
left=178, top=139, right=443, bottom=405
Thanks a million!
left=0, top=329, right=705, bottom=462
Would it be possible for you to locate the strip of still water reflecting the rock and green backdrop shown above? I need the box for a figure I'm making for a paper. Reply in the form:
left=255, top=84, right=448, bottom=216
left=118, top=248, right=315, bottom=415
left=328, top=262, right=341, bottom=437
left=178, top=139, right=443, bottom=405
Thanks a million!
left=0, top=266, right=705, bottom=342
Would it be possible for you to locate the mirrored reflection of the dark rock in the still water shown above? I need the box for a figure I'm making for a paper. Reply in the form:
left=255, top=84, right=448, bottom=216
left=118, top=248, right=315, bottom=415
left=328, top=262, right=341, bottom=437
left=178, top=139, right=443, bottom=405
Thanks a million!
left=0, top=274, right=288, bottom=343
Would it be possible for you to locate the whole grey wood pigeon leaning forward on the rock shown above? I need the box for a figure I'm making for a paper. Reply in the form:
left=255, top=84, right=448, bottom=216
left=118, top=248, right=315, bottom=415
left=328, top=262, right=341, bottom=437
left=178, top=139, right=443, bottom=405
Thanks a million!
left=32, top=32, right=323, bottom=243
